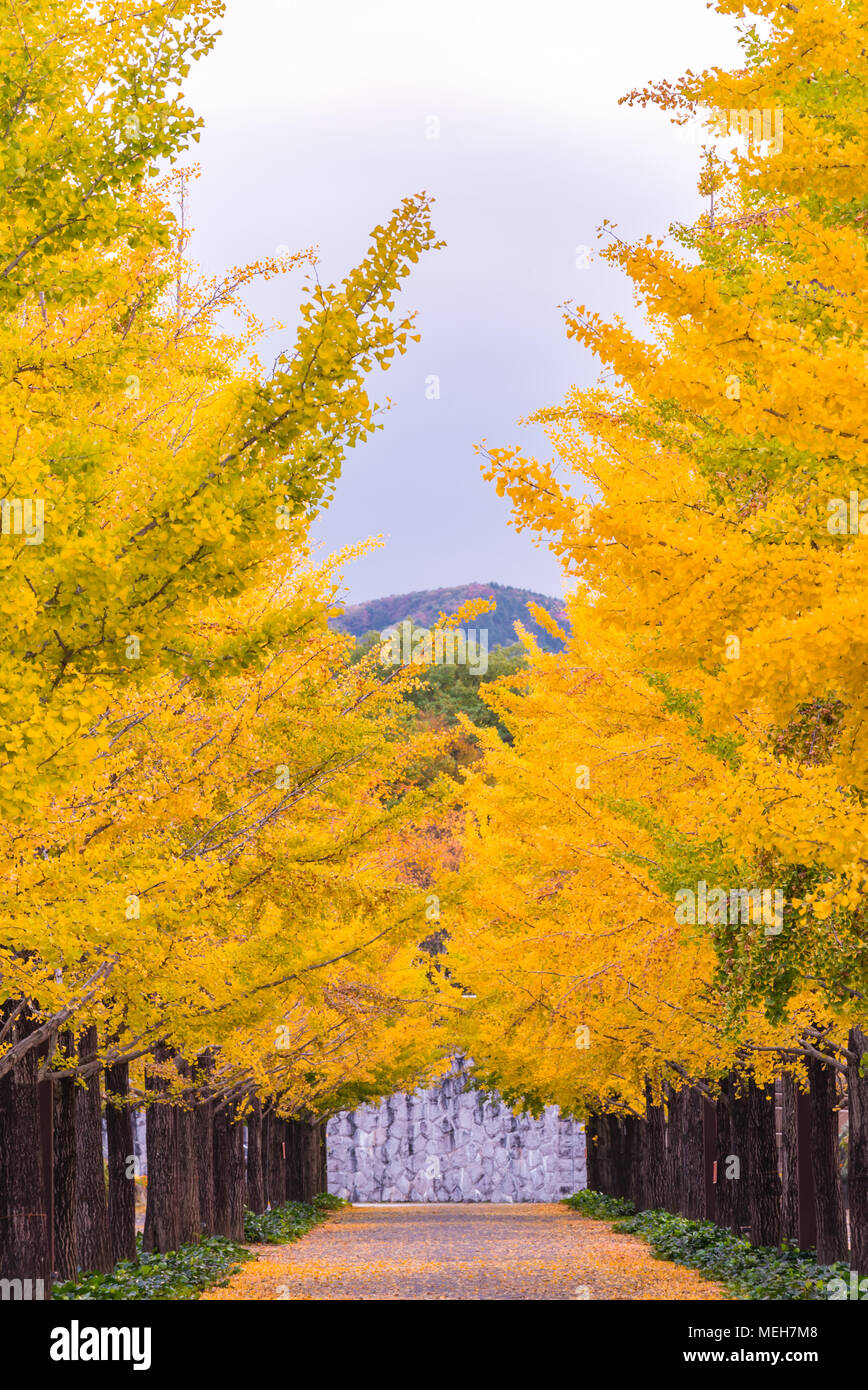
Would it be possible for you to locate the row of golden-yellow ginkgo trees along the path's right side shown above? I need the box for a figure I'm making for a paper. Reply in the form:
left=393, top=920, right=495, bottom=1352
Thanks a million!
left=445, top=0, right=868, bottom=1268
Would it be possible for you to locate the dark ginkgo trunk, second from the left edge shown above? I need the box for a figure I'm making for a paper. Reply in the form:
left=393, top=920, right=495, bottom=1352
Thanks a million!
left=75, top=1027, right=114, bottom=1273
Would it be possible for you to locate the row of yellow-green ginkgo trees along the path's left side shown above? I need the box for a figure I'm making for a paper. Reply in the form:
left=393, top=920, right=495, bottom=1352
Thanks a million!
left=0, top=0, right=459, bottom=1276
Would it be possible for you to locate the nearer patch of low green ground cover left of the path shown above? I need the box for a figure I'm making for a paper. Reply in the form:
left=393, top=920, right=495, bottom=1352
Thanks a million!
left=51, top=1236, right=256, bottom=1302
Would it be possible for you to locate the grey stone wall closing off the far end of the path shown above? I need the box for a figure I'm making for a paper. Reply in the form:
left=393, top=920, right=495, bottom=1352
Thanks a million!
left=328, top=1062, right=586, bottom=1202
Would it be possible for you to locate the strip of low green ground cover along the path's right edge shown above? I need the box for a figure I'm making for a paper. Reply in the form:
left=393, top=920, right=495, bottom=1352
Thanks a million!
left=565, top=1191, right=850, bottom=1302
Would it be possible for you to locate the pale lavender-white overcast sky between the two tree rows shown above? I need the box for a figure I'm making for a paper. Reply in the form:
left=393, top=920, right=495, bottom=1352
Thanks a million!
left=186, top=0, right=739, bottom=602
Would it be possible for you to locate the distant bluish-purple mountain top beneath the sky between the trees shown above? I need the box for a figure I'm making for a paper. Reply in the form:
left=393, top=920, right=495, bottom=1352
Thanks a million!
left=332, top=584, right=565, bottom=652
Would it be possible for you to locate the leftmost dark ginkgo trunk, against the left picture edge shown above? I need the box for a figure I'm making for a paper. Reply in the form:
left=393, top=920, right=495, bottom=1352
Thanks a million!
left=0, top=1001, right=51, bottom=1300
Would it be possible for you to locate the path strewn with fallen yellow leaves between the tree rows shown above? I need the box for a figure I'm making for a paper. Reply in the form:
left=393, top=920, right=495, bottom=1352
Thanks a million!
left=204, top=1204, right=722, bottom=1300
